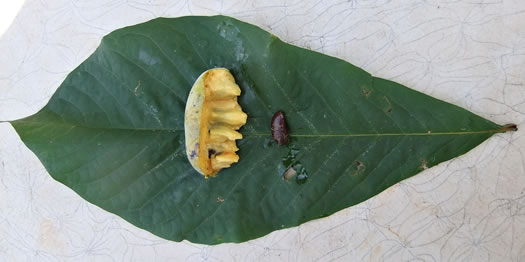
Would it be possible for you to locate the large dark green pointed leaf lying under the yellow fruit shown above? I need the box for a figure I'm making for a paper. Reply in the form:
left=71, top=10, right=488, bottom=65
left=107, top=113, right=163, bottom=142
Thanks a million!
left=12, top=16, right=506, bottom=244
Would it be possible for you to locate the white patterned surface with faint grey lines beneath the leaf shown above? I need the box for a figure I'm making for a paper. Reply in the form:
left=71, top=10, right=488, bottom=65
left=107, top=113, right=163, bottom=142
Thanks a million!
left=0, top=0, right=525, bottom=261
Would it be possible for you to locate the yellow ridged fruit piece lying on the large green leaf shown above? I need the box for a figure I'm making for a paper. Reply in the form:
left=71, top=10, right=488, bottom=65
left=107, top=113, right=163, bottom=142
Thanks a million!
left=185, top=68, right=247, bottom=178
